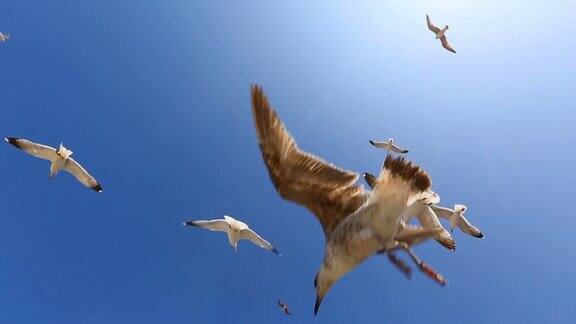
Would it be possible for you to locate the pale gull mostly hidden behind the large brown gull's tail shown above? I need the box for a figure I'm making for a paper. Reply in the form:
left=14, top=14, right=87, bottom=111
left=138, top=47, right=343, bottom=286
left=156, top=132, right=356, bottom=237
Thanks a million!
left=362, top=172, right=456, bottom=251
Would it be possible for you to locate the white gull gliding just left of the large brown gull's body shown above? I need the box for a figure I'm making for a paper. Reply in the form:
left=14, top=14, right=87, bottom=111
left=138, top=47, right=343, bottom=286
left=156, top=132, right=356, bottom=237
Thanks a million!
left=182, top=215, right=279, bottom=254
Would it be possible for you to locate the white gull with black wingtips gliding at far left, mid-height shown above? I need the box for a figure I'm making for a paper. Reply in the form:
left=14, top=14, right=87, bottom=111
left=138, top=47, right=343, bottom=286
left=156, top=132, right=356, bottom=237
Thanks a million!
left=4, top=137, right=102, bottom=192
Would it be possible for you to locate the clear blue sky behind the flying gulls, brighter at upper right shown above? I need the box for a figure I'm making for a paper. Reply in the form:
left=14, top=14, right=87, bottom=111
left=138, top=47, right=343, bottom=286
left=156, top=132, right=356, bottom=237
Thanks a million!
left=0, top=0, right=576, bottom=324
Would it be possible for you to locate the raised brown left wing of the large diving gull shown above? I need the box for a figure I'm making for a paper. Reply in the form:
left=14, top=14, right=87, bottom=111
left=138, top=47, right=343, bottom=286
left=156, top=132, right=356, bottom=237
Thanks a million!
left=252, top=86, right=366, bottom=237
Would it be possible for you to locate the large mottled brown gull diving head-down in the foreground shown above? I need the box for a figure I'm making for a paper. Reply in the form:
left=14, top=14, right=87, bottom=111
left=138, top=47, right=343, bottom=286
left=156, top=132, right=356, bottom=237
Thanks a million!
left=251, top=85, right=444, bottom=314
